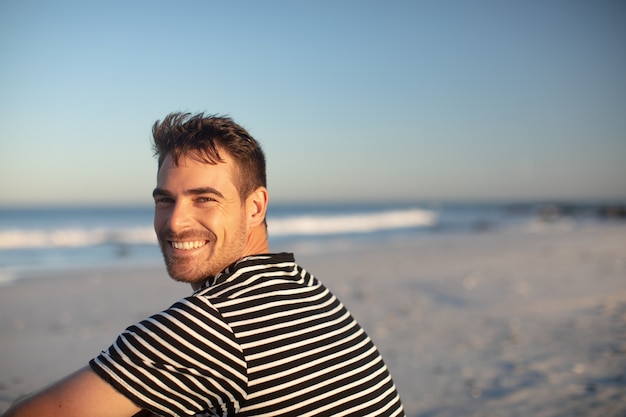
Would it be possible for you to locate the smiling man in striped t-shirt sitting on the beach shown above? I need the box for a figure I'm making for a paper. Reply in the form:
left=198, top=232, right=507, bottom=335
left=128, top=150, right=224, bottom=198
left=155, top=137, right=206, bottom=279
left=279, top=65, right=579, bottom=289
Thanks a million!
left=6, top=113, right=404, bottom=417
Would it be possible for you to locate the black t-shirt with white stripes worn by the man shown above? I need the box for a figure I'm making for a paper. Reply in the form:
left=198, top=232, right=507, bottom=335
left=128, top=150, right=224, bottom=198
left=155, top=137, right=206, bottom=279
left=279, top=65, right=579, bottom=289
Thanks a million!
left=90, top=253, right=404, bottom=417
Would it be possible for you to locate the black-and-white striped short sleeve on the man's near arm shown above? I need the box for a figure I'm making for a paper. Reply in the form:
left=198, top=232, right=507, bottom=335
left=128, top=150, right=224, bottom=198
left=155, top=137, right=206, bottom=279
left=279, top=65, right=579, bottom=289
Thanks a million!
left=89, top=296, right=248, bottom=416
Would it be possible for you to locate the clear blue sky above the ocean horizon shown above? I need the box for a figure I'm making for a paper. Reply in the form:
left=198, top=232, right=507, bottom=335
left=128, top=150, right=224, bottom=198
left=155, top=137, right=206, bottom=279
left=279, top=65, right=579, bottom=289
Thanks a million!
left=0, top=0, right=626, bottom=205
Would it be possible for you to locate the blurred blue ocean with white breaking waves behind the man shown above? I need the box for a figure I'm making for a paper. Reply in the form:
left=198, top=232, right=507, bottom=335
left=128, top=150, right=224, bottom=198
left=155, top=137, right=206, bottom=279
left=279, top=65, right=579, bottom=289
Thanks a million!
left=0, top=203, right=616, bottom=282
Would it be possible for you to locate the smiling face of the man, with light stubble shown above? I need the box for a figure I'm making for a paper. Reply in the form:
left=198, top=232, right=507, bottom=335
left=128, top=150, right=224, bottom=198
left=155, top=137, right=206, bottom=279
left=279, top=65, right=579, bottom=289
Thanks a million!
left=154, top=152, right=248, bottom=285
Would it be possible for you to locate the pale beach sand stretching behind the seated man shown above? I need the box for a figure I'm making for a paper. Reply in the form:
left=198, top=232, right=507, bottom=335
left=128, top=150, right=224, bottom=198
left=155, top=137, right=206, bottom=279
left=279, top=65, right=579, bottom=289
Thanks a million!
left=0, top=222, right=626, bottom=417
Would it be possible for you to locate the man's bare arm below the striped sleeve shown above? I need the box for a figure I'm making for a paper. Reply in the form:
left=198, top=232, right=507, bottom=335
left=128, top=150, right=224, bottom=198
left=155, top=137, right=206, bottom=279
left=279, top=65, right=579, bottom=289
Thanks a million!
left=5, top=367, right=140, bottom=417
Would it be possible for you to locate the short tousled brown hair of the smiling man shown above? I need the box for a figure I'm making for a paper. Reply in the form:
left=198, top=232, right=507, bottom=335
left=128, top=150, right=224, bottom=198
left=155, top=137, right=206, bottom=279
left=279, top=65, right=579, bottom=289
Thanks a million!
left=152, top=113, right=267, bottom=199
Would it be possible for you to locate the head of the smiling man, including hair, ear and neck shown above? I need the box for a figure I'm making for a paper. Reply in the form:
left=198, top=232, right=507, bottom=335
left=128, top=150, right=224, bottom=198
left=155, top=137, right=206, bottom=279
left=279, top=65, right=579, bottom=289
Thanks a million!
left=153, top=113, right=268, bottom=287
